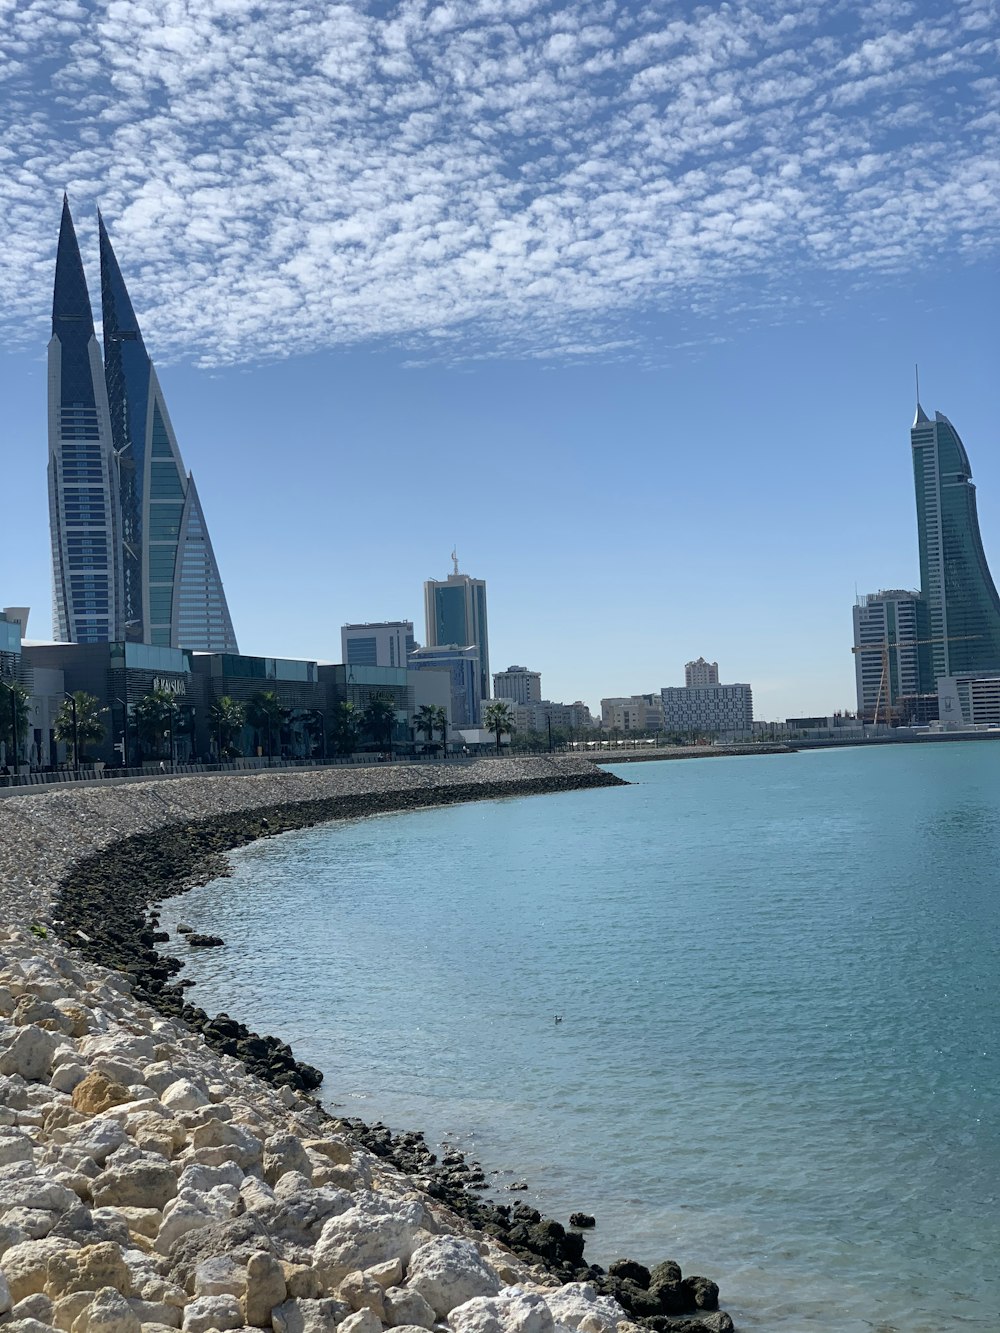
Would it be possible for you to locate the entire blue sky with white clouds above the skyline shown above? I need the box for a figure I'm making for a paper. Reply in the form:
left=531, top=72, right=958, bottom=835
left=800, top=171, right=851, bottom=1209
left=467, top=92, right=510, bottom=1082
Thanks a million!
left=0, top=0, right=1000, bottom=718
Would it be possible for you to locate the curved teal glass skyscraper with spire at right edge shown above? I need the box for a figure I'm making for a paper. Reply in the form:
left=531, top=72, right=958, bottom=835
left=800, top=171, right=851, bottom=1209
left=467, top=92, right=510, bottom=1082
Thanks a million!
left=909, top=403, right=1000, bottom=692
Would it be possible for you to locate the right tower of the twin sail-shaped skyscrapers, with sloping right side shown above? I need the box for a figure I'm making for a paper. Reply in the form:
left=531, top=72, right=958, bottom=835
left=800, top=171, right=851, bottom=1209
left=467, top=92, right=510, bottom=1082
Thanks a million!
left=97, top=215, right=239, bottom=653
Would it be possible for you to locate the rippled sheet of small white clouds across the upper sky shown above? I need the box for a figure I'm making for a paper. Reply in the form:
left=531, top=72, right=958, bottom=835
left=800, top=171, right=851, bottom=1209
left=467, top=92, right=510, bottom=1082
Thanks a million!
left=0, top=0, right=1000, bottom=363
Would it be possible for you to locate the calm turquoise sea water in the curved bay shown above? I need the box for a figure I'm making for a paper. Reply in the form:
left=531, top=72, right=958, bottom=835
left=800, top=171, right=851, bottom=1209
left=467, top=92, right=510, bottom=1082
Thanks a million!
left=164, top=742, right=1000, bottom=1333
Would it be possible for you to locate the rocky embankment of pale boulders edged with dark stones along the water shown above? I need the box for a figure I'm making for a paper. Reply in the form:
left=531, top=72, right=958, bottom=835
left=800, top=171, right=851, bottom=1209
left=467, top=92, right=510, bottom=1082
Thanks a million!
left=0, top=765, right=732, bottom=1333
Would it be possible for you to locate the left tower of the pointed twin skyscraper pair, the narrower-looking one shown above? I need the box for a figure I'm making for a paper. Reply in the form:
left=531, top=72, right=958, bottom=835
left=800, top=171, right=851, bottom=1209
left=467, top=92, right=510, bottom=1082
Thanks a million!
left=48, top=196, right=125, bottom=644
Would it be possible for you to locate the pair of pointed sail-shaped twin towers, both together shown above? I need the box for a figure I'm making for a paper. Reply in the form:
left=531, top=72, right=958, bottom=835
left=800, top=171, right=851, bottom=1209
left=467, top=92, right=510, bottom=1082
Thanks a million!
left=48, top=197, right=239, bottom=653
